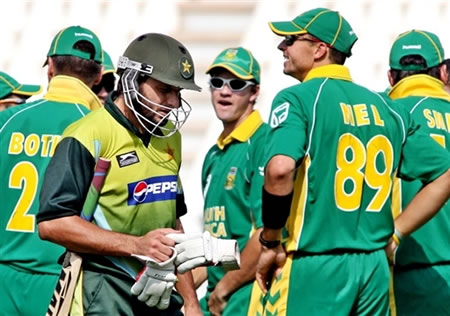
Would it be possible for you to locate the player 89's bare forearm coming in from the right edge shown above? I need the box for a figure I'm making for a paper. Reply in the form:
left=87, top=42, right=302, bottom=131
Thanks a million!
left=395, top=169, right=450, bottom=236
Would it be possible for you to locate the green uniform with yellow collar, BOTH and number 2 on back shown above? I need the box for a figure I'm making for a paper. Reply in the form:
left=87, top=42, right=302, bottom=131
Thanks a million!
left=0, top=76, right=101, bottom=315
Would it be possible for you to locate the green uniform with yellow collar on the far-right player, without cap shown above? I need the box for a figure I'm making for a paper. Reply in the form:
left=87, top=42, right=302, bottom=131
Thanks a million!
left=389, top=75, right=450, bottom=315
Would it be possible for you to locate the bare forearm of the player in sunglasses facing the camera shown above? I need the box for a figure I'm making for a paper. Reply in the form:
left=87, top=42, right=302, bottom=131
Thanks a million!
left=216, top=229, right=262, bottom=297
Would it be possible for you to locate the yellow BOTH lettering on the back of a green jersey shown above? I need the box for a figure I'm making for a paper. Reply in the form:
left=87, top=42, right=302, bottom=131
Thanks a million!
left=8, top=132, right=61, bottom=157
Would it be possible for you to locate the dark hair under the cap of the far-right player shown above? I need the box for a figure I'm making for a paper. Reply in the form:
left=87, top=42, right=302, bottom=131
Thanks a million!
left=391, top=55, right=442, bottom=85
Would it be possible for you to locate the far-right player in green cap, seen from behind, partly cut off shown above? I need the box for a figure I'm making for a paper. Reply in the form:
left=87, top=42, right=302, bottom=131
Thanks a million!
left=388, top=30, right=450, bottom=315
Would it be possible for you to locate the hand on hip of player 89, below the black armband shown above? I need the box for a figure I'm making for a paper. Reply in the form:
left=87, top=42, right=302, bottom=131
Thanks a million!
left=256, top=245, right=286, bottom=294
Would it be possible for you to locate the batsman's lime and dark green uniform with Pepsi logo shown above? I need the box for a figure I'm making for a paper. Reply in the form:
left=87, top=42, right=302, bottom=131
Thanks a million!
left=38, top=95, right=186, bottom=315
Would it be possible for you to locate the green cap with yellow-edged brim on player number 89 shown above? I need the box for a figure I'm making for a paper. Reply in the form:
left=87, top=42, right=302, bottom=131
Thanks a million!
left=269, top=8, right=358, bottom=57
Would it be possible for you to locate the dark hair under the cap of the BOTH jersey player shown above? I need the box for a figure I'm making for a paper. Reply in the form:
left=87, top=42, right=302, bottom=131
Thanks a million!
left=51, top=40, right=102, bottom=86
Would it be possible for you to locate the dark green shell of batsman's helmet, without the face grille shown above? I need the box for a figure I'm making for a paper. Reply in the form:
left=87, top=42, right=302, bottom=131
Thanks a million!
left=117, top=33, right=201, bottom=91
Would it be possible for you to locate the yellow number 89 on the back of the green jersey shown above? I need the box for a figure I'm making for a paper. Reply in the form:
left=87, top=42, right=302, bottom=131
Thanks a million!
left=334, top=133, right=394, bottom=212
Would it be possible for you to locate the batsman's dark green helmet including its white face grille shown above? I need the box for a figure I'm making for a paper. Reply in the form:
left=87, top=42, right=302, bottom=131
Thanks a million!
left=117, top=33, right=201, bottom=137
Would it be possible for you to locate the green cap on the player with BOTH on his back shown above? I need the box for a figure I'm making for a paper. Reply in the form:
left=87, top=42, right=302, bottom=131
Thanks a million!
left=47, top=26, right=103, bottom=64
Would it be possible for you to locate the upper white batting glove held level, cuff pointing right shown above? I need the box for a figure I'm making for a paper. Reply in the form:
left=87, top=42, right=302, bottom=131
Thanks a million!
left=166, top=231, right=240, bottom=273
